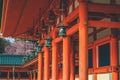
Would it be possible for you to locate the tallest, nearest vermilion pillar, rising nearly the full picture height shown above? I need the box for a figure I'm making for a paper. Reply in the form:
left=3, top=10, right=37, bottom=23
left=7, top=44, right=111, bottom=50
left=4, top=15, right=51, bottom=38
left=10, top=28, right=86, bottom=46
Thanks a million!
left=79, top=2, right=88, bottom=80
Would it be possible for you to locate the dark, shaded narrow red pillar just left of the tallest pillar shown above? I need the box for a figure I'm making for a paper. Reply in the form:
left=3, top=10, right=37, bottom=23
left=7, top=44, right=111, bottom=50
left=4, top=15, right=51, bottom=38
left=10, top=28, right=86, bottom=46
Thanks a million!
left=70, top=42, right=75, bottom=80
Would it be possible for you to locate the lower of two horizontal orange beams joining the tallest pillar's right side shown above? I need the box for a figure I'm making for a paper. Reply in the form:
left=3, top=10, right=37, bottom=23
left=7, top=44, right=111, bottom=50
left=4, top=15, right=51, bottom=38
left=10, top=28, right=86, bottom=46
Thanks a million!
left=88, top=20, right=120, bottom=28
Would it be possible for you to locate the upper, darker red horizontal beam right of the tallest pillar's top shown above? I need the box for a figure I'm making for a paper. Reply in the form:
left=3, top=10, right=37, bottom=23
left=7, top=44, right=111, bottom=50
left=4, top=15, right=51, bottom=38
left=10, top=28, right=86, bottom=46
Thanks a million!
left=88, top=4, right=120, bottom=14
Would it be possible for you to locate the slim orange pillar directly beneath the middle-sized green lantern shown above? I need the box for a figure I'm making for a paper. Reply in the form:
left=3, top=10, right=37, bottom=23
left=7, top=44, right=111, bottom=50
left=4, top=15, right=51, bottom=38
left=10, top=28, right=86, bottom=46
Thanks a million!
left=44, top=47, right=49, bottom=80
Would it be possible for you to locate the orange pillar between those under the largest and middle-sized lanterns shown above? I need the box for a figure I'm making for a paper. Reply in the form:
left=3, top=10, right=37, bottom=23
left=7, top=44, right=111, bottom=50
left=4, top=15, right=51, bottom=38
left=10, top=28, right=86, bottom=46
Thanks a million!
left=52, top=41, right=58, bottom=80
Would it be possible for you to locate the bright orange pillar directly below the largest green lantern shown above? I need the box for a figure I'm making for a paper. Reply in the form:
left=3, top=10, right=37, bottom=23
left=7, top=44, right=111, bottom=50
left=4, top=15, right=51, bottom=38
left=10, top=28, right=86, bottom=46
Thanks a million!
left=63, top=37, right=70, bottom=80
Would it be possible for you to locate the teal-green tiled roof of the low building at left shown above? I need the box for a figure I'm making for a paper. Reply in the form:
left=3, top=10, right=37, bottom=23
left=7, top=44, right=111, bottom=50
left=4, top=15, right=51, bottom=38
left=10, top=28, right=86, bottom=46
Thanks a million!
left=0, top=54, right=24, bottom=66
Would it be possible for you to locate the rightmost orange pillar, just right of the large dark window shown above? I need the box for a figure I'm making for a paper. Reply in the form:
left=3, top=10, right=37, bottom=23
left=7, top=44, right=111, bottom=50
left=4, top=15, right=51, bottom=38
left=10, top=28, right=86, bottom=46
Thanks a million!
left=110, top=37, right=119, bottom=80
